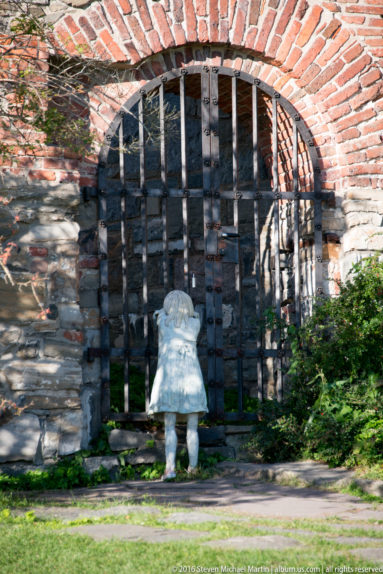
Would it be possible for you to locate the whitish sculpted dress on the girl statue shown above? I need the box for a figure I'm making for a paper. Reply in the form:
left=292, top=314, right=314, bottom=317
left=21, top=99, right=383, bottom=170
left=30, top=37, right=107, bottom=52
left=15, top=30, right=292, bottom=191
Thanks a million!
left=148, top=309, right=208, bottom=420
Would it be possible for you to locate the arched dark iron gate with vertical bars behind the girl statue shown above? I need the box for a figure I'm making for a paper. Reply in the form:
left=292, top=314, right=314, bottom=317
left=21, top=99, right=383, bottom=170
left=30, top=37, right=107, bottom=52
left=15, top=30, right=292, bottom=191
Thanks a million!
left=94, top=66, right=329, bottom=420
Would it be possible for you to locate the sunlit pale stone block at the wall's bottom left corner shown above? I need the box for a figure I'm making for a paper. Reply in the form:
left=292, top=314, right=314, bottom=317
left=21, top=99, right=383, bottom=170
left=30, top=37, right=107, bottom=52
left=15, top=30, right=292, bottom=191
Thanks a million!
left=0, top=413, right=41, bottom=462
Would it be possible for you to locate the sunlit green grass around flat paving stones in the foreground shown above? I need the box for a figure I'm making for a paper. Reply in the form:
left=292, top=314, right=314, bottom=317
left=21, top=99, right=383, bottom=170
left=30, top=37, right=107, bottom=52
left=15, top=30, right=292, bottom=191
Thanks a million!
left=0, top=503, right=383, bottom=574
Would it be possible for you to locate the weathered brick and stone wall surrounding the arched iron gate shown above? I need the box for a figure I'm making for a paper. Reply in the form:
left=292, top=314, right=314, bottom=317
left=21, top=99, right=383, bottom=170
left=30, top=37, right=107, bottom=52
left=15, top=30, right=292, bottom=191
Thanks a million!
left=0, top=0, right=383, bottom=462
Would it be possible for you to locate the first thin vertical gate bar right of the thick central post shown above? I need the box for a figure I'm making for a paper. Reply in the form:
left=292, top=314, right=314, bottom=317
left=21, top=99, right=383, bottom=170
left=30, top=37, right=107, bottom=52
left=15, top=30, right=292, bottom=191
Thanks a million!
left=231, top=76, right=243, bottom=415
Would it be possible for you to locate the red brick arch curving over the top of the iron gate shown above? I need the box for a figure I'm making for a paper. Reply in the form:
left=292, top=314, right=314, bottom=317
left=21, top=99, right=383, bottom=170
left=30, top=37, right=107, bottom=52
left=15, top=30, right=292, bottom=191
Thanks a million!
left=55, top=0, right=383, bottom=195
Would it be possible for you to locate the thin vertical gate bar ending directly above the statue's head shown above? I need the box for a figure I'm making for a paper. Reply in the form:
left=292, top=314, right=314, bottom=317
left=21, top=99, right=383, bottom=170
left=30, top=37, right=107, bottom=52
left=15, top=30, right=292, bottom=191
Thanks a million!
left=180, top=74, right=190, bottom=293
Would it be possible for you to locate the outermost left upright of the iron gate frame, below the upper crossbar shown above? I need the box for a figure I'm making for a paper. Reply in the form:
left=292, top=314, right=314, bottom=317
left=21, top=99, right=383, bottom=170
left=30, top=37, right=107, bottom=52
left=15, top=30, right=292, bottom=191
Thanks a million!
left=98, top=189, right=110, bottom=419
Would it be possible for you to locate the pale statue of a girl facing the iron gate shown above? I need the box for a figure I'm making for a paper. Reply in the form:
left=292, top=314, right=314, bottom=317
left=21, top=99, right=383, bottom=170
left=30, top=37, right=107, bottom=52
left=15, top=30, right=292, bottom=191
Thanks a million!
left=148, top=291, right=208, bottom=480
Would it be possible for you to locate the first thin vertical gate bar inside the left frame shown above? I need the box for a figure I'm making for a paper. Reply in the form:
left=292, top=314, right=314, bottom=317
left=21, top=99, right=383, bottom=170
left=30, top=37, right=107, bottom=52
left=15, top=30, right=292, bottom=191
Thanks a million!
left=119, top=118, right=130, bottom=413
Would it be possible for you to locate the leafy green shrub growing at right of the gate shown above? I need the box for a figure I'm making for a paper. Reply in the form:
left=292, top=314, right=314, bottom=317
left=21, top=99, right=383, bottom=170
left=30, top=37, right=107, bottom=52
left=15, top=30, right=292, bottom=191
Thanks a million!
left=249, top=256, right=383, bottom=466
